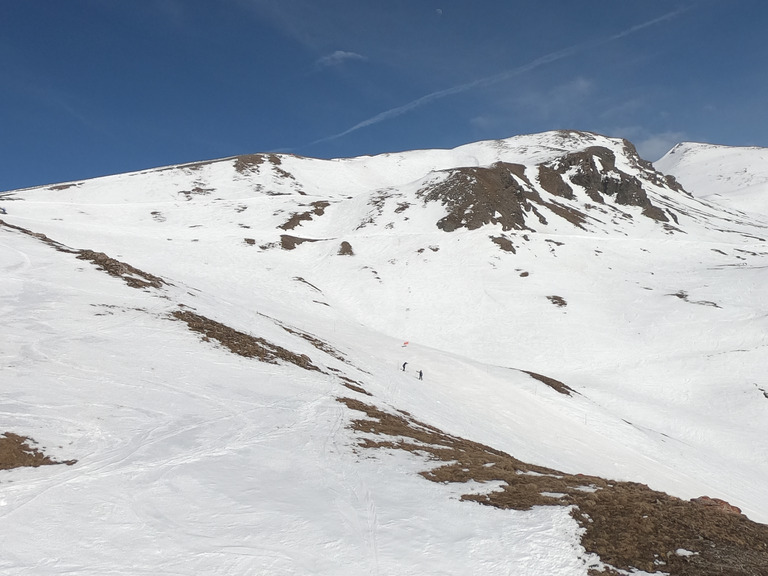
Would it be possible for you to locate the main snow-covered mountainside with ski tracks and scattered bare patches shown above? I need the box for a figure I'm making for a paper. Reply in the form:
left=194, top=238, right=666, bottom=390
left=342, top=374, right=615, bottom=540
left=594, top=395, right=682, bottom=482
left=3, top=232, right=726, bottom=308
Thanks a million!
left=0, top=132, right=768, bottom=576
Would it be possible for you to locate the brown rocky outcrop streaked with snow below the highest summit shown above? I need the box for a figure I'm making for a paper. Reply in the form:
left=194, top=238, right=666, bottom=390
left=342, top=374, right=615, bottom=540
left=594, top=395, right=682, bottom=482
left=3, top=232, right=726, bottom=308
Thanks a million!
left=419, top=142, right=687, bottom=232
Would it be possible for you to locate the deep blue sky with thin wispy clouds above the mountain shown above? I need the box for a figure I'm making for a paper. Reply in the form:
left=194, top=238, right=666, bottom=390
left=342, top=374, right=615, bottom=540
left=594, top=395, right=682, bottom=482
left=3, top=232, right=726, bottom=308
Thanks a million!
left=0, top=0, right=768, bottom=190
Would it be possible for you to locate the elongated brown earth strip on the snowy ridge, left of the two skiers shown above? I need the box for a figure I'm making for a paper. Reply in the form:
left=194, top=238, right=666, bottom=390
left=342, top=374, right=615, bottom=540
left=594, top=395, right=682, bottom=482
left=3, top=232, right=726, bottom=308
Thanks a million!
left=171, top=310, right=321, bottom=372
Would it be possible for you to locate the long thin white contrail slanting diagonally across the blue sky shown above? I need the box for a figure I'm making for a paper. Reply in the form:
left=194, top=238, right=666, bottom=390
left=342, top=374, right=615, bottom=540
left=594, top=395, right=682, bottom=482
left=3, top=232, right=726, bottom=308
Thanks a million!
left=309, top=7, right=690, bottom=146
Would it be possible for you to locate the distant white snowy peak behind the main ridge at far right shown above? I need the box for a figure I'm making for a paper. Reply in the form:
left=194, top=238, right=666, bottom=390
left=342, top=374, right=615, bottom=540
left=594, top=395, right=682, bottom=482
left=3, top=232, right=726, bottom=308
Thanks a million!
left=654, top=142, right=768, bottom=216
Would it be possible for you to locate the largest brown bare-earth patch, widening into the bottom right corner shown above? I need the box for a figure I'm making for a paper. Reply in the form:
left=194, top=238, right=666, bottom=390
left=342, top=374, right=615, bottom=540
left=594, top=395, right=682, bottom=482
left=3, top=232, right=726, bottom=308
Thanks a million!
left=339, top=398, right=768, bottom=576
